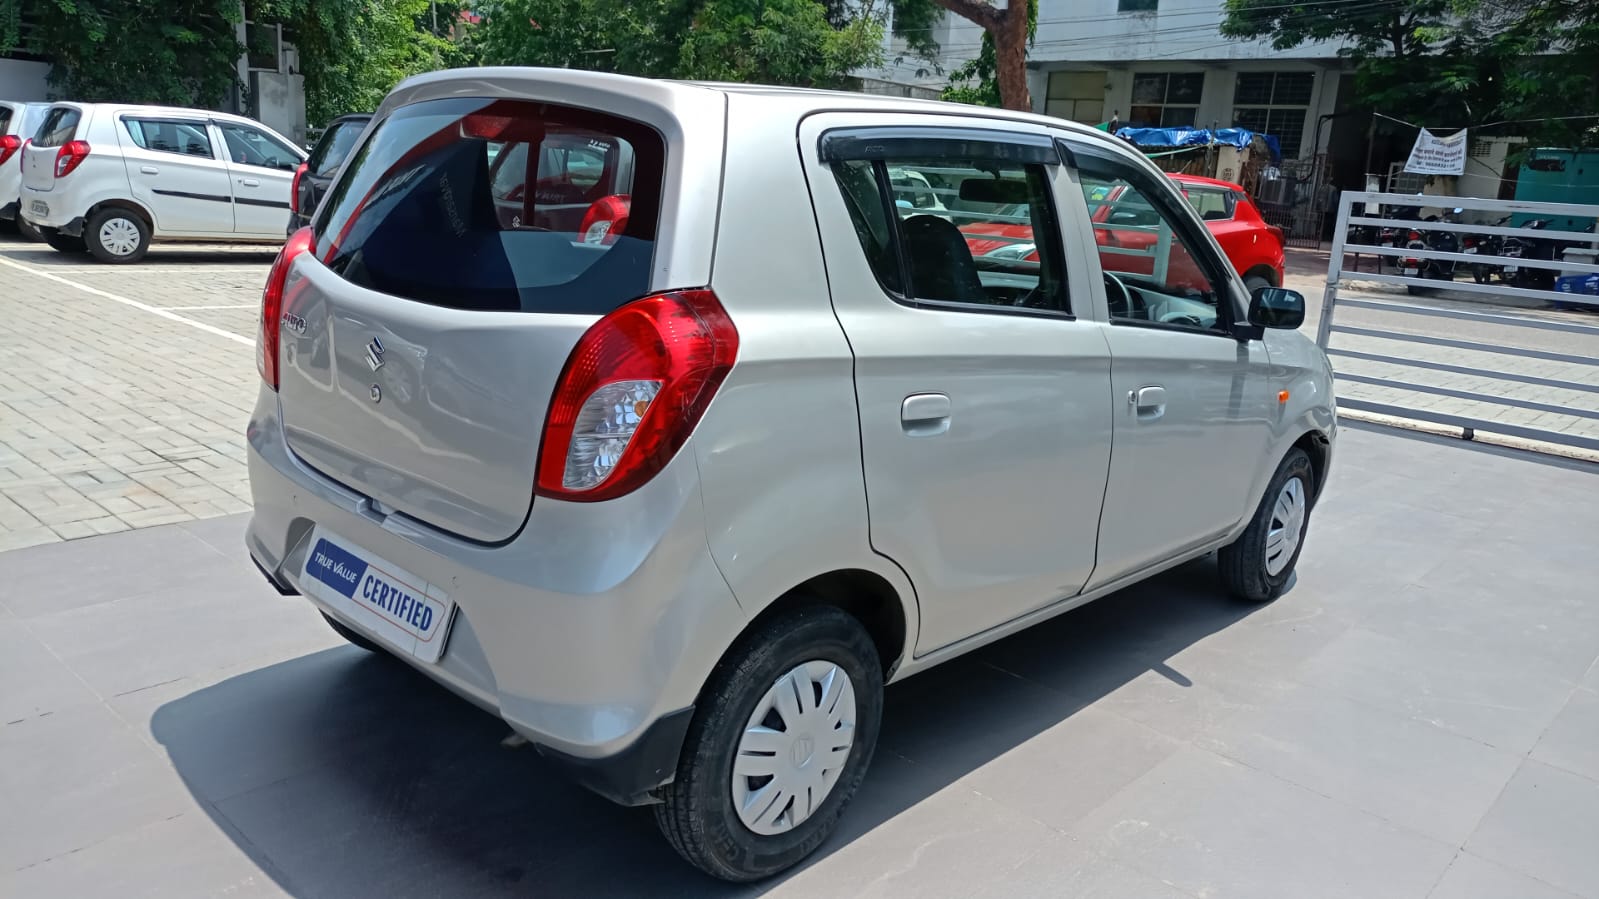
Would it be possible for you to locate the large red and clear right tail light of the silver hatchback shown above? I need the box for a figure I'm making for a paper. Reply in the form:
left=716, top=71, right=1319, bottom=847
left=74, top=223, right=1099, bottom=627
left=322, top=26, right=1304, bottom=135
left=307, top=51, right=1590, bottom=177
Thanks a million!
left=537, top=290, right=739, bottom=502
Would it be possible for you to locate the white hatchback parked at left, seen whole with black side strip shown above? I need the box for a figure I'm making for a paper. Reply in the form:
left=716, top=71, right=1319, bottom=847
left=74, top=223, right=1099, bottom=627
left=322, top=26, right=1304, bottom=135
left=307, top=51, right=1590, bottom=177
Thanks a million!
left=21, top=102, right=305, bottom=262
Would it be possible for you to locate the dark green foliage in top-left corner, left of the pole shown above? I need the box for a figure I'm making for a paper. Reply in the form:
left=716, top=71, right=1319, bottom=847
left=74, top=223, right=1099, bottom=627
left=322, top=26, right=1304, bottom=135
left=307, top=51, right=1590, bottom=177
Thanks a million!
left=0, top=0, right=243, bottom=106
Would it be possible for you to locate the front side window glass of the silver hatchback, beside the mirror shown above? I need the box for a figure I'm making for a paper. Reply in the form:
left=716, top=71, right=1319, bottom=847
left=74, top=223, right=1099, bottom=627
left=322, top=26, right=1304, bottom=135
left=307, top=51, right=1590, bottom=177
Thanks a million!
left=1078, top=154, right=1228, bottom=330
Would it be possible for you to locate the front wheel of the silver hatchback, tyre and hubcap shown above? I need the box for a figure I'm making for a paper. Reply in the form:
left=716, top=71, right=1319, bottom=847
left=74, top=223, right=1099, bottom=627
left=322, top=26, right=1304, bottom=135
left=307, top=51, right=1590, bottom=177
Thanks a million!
left=1217, top=446, right=1316, bottom=603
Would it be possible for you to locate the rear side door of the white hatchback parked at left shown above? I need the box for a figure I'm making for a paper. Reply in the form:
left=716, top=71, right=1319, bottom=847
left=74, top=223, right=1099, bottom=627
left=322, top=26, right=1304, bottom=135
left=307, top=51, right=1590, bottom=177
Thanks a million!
left=117, top=114, right=233, bottom=234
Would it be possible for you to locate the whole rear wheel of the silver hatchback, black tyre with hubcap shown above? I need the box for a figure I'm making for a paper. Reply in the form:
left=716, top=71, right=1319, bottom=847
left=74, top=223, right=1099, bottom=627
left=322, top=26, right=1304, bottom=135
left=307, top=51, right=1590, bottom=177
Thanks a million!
left=656, top=606, right=883, bottom=881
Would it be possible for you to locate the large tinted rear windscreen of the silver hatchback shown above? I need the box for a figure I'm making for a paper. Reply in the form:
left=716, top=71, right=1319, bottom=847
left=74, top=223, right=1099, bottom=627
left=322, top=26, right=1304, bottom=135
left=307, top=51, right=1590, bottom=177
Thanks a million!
left=315, top=98, right=665, bottom=315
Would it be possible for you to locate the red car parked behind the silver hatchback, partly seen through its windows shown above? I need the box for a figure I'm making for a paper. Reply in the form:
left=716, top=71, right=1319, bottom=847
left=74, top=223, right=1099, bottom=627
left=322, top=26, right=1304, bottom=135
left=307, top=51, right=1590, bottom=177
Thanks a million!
left=961, top=174, right=1282, bottom=291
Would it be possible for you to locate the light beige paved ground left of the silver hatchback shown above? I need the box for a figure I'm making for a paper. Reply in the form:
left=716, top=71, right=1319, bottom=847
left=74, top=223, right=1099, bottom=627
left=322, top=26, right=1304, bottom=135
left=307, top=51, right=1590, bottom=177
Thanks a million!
left=0, top=238, right=272, bottom=550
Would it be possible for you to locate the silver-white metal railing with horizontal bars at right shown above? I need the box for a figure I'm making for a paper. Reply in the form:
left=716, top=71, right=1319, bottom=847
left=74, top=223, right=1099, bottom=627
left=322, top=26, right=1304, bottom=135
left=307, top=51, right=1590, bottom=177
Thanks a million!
left=1316, top=192, right=1599, bottom=451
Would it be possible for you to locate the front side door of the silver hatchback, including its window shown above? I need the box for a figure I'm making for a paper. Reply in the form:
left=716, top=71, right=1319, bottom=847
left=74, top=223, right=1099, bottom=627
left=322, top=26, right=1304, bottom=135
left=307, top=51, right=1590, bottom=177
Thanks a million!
left=1070, top=142, right=1276, bottom=589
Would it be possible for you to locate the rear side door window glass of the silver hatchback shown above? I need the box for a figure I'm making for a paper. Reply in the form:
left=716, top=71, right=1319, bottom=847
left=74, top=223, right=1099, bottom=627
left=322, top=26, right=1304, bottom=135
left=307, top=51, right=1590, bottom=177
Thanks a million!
left=835, top=151, right=1070, bottom=312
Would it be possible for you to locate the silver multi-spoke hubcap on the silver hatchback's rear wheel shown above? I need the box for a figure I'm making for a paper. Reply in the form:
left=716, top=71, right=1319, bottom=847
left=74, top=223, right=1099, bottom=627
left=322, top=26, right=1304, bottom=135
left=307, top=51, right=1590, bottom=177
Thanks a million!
left=732, top=661, right=855, bottom=835
